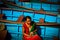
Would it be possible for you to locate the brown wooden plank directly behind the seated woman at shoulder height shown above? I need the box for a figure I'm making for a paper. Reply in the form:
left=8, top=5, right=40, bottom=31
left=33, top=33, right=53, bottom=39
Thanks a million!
left=0, top=20, right=60, bottom=26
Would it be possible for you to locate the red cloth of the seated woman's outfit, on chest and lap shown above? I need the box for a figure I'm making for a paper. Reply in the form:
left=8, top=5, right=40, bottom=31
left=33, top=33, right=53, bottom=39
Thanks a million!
left=23, top=23, right=42, bottom=40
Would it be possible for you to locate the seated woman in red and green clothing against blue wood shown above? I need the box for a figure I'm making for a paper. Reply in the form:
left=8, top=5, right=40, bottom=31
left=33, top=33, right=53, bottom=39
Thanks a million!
left=23, top=16, right=41, bottom=40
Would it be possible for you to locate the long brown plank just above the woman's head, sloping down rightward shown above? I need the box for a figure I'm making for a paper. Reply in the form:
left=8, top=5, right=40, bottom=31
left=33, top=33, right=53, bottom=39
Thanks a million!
left=0, top=8, right=60, bottom=16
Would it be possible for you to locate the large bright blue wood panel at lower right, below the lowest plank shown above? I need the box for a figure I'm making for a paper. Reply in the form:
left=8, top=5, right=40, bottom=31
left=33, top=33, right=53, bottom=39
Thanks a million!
left=45, top=26, right=59, bottom=38
